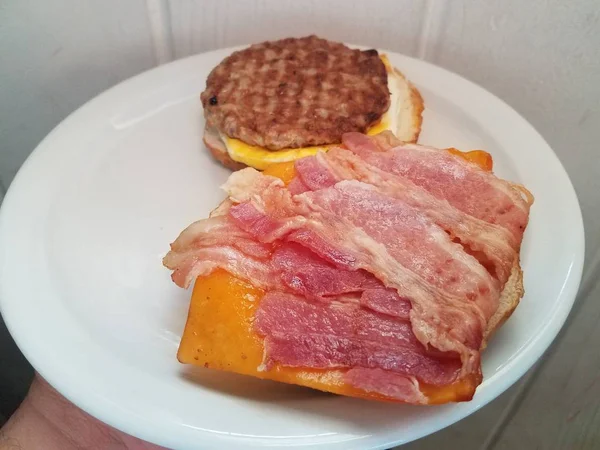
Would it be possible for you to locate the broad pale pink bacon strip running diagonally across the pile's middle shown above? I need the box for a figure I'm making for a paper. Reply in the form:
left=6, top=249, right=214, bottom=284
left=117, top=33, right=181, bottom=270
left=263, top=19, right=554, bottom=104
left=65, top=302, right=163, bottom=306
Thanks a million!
left=306, top=181, right=497, bottom=317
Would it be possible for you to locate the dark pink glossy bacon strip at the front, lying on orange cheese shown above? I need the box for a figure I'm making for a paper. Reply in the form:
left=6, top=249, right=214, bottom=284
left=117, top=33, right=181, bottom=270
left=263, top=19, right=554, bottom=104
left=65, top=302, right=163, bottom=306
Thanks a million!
left=254, top=292, right=461, bottom=385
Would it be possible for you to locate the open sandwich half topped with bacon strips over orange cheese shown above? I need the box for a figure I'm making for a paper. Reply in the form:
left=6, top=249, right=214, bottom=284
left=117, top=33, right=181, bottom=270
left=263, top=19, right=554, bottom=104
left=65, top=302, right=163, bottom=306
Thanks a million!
left=163, top=131, right=533, bottom=404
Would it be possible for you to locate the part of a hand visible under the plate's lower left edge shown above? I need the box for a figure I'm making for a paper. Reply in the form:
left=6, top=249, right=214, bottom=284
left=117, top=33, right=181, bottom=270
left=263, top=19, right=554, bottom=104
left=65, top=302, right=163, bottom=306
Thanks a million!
left=0, top=375, right=162, bottom=450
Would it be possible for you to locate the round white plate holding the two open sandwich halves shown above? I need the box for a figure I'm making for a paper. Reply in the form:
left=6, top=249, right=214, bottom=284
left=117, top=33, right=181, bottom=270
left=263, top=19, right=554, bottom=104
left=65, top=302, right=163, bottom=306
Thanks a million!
left=0, top=49, right=584, bottom=449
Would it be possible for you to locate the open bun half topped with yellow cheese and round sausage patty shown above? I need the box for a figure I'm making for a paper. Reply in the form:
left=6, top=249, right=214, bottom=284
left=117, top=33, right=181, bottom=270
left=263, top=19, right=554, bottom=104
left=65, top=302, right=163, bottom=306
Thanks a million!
left=201, top=36, right=423, bottom=170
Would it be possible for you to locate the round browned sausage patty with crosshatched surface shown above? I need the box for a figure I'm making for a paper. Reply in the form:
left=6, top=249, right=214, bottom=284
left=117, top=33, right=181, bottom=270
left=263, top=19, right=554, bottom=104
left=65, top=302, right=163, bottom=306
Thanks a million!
left=201, top=36, right=390, bottom=150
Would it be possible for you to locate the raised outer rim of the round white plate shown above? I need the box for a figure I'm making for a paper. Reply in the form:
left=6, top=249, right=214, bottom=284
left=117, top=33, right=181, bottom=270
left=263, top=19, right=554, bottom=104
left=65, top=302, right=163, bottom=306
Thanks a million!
left=0, top=44, right=585, bottom=448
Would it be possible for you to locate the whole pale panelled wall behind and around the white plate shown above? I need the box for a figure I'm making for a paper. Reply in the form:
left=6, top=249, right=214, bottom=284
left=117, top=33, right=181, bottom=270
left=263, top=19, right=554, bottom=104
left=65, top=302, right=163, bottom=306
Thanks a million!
left=0, top=0, right=600, bottom=450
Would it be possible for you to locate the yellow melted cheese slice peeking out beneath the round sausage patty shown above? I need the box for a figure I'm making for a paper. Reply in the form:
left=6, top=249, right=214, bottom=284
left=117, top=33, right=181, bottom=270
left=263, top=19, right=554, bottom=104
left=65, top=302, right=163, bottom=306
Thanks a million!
left=220, top=55, right=401, bottom=170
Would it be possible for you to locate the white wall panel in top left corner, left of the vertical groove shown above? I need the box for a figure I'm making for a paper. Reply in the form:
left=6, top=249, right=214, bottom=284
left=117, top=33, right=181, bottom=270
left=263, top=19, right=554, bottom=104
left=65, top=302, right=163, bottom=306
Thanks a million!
left=0, top=0, right=155, bottom=187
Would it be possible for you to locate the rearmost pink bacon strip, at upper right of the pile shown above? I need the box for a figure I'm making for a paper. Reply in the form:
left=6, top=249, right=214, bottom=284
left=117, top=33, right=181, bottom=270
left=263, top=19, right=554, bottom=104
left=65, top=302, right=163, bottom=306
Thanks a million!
left=343, top=133, right=530, bottom=242
